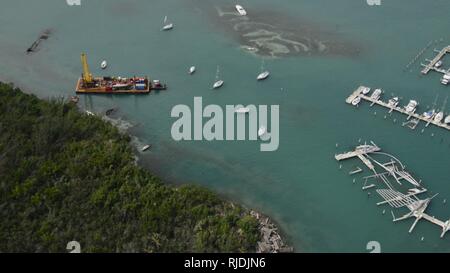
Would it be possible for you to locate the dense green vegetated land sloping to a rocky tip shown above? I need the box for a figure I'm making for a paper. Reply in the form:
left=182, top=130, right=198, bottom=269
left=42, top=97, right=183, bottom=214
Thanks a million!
left=0, top=82, right=293, bottom=252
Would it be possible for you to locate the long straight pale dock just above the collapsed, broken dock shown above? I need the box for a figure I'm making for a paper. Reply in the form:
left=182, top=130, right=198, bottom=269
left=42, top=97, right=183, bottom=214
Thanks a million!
left=345, top=85, right=450, bottom=130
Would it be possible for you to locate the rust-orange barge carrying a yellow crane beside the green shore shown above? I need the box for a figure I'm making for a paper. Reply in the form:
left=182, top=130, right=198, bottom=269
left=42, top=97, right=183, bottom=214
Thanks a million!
left=75, top=53, right=166, bottom=94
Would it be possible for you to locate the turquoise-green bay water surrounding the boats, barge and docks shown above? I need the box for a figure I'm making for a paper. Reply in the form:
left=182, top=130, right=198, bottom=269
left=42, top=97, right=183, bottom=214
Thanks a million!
left=0, top=0, right=450, bottom=252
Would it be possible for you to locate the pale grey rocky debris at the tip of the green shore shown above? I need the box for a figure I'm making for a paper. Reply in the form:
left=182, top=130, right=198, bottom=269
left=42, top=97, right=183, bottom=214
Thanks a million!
left=250, top=210, right=294, bottom=253
